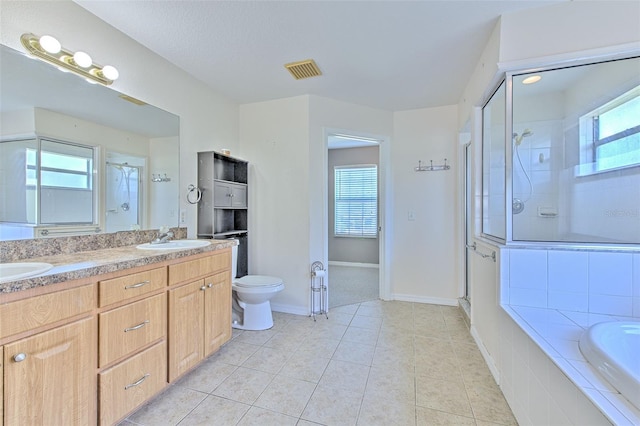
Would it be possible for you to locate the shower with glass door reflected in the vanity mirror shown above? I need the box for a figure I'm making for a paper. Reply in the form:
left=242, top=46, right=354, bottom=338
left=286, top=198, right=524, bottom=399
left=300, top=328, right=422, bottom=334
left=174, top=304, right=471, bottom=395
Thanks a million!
left=105, top=161, right=142, bottom=232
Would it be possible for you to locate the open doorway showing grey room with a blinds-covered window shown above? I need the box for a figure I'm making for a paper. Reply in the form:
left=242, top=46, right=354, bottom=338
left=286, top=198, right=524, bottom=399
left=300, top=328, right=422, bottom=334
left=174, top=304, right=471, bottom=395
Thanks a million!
left=325, top=133, right=382, bottom=308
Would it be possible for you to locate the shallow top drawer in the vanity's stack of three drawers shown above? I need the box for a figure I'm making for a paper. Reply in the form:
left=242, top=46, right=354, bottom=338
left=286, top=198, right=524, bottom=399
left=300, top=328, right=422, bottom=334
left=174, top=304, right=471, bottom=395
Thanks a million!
left=99, top=268, right=167, bottom=307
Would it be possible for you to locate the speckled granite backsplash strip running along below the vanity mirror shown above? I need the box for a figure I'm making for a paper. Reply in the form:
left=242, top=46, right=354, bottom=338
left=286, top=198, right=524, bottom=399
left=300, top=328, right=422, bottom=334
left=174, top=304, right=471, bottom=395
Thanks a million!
left=0, top=228, right=187, bottom=263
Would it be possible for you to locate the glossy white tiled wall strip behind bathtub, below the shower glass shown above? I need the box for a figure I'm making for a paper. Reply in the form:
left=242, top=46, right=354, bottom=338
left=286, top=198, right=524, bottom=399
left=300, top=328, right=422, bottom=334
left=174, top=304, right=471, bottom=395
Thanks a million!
left=501, top=248, right=640, bottom=318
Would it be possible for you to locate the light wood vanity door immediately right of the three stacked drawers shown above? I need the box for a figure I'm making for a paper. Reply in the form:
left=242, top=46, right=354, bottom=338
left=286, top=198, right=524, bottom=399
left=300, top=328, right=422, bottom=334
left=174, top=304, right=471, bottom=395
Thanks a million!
left=169, top=280, right=206, bottom=382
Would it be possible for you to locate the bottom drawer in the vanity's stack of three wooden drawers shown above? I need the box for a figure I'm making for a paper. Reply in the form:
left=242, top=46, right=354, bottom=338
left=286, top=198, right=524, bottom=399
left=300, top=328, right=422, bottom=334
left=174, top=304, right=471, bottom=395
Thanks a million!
left=99, top=340, right=167, bottom=425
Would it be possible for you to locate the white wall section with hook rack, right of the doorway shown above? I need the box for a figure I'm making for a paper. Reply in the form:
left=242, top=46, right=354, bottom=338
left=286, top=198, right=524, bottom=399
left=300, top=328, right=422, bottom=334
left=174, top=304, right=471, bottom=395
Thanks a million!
left=391, top=105, right=460, bottom=304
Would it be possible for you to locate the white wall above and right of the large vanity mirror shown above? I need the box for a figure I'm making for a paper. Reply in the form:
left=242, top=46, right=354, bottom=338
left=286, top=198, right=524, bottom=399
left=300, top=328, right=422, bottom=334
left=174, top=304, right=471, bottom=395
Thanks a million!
left=0, top=1, right=238, bottom=238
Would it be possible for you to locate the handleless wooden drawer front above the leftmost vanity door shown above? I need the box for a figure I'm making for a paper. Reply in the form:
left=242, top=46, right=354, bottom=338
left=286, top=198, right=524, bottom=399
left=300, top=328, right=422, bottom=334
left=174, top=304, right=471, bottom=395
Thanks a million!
left=0, top=284, right=95, bottom=339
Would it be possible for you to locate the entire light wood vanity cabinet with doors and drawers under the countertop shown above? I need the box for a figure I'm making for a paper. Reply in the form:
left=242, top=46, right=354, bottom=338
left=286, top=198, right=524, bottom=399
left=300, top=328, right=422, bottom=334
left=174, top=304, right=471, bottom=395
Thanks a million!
left=0, top=249, right=231, bottom=426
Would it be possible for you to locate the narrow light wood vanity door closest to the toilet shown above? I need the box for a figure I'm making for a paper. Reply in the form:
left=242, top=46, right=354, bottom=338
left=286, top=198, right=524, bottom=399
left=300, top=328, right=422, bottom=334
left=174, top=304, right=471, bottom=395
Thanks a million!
left=204, top=271, right=231, bottom=356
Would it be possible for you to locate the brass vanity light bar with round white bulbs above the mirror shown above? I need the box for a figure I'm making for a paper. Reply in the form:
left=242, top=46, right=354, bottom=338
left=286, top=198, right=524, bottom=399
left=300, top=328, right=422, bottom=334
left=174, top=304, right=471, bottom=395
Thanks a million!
left=20, top=33, right=119, bottom=86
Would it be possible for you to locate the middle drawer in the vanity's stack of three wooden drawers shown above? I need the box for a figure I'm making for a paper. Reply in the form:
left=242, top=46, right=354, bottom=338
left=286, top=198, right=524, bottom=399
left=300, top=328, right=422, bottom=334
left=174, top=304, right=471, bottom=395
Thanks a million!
left=98, top=293, right=167, bottom=367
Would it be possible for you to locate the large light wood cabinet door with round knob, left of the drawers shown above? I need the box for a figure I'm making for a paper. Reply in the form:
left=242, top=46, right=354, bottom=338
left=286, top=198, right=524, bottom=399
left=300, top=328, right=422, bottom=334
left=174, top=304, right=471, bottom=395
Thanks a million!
left=4, top=318, right=97, bottom=425
